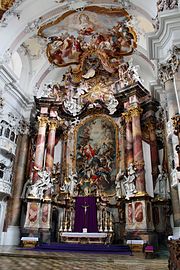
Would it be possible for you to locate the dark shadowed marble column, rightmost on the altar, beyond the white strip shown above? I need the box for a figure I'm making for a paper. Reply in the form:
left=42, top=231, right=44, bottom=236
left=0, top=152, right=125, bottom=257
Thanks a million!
left=146, top=117, right=159, bottom=188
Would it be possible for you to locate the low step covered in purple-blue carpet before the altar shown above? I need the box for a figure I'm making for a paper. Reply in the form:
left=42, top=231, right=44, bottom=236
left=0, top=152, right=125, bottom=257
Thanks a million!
left=34, top=243, right=132, bottom=255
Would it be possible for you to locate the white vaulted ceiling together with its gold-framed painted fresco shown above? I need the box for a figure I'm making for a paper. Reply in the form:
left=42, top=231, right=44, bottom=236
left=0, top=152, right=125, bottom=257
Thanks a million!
left=0, top=0, right=157, bottom=99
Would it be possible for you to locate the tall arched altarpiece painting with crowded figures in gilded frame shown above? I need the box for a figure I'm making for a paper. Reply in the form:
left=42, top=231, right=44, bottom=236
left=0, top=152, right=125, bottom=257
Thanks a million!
left=76, top=116, right=117, bottom=195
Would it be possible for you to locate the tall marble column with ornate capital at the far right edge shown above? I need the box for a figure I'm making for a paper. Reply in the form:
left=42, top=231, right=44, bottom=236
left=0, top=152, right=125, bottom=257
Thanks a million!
left=158, top=50, right=180, bottom=230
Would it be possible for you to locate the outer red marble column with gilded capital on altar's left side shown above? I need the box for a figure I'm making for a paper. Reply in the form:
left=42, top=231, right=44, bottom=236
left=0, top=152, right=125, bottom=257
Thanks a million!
left=33, top=116, right=48, bottom=182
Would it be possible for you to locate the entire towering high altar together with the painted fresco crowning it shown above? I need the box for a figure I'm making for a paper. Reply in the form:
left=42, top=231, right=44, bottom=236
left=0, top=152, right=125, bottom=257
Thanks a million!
left=22, top=6, right=169, bottom=246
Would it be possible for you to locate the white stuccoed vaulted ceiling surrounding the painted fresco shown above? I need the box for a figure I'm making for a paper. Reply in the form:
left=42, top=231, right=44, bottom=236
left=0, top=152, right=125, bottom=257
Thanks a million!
left=0, top=0, right=157, bottom=100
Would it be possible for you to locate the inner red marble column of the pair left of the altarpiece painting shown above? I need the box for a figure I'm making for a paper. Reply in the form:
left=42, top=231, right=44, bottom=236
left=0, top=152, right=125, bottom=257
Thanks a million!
left=45, top=120, right=57, bottom=172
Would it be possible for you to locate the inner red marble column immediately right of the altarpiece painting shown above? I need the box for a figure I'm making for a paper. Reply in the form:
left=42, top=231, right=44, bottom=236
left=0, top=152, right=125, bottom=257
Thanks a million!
left=123, top=112, right=133, bottom=168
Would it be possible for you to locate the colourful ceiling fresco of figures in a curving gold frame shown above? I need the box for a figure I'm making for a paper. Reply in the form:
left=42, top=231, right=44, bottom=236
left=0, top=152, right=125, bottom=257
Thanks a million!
left=38, top=6, right=137, bottom=82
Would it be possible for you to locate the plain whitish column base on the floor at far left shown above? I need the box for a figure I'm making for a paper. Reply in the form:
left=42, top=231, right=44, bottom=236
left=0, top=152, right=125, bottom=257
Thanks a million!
left=3, top=226, right=20, bottom=246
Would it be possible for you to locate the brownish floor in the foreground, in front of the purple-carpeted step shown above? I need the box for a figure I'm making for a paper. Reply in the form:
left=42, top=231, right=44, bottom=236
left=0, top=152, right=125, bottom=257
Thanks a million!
left=0, top=247, right=168, bottom=270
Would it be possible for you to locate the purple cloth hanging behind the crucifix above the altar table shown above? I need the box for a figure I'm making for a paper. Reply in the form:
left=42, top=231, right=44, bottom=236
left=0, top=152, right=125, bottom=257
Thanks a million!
left=74, top=197, right=98, bottom=232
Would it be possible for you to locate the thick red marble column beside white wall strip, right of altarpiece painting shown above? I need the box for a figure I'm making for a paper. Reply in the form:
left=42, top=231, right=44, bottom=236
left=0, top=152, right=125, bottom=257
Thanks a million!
left=129, top=107, right=145, bottom=195
